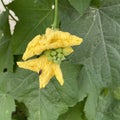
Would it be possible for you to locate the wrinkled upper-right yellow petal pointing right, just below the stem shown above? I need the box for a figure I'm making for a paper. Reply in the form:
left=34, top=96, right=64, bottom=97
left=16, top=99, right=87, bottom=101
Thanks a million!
left=45, top=28, right=83, bottom=48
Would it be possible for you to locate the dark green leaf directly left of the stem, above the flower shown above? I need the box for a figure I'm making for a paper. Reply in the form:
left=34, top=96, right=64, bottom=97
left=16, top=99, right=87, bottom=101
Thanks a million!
left=8, top=0, right=54, bottom=54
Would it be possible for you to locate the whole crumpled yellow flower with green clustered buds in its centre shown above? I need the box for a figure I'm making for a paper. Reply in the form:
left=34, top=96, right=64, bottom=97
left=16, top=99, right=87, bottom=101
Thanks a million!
left=17, top=28, right=83, bottom=88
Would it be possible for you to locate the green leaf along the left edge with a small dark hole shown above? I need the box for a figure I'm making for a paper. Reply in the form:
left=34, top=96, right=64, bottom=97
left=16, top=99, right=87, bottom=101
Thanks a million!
left=0, top=12, right=13, bottom=72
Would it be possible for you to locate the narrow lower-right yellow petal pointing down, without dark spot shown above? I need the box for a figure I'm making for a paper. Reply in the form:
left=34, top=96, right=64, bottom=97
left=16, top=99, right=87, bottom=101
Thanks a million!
left=53, top=63, right=64, bottom=85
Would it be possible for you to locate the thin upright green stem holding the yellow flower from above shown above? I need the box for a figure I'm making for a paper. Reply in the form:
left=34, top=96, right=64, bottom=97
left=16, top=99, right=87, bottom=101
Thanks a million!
left=52, top=0, right=58, bottom=29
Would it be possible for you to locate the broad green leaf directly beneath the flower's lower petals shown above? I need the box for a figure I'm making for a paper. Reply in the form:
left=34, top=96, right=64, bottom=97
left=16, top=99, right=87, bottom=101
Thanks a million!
left=0, top=62, right=80, bottom=120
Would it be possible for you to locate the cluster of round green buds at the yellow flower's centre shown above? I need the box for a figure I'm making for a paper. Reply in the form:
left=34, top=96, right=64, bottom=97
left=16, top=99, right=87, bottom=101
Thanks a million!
left=43, top=48, right=65, bottom=64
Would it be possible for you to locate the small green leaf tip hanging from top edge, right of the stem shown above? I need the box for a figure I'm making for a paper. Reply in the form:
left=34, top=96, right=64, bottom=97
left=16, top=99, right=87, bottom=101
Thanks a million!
left=69, top=0, right=91, bottom=15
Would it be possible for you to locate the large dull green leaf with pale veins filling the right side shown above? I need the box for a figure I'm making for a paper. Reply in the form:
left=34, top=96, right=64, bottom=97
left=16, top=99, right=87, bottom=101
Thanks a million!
left=61, top=0, right=120, bottom=120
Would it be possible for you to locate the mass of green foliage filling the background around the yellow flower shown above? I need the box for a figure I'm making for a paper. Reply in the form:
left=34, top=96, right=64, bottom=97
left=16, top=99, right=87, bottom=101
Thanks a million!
left=0, top=0, right=120, bottom=120
